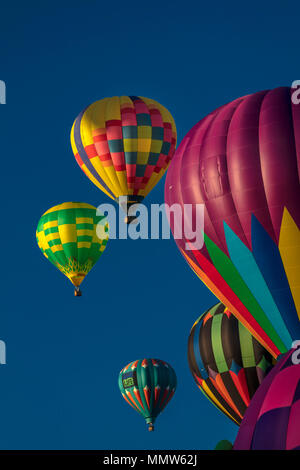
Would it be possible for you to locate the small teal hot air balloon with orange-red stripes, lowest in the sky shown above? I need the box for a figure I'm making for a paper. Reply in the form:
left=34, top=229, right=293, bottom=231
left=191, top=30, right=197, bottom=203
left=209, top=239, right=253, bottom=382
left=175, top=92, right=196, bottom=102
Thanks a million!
left=119, top=359, right=177, bottom=431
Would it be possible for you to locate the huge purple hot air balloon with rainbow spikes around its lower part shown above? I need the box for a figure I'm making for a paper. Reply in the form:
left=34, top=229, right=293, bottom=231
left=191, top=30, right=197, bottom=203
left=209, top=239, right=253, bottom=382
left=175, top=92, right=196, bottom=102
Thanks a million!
left=165, top=87, right=300, bottom=358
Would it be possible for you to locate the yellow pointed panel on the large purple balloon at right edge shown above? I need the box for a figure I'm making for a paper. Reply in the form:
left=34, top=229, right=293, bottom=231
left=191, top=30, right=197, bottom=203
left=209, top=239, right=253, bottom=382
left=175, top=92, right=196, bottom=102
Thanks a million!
left=278, top=208, right=300, bottom=320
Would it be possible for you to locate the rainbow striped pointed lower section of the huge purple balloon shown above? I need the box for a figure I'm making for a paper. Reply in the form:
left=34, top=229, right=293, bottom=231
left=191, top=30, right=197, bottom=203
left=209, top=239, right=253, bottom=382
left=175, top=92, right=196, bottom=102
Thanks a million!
left=181, top=209, right=300, bottom=357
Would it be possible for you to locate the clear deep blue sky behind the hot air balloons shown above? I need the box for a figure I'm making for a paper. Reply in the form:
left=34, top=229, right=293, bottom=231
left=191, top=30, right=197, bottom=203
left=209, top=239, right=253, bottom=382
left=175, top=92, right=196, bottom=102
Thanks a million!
left=0, top=0, right=300, bottom=449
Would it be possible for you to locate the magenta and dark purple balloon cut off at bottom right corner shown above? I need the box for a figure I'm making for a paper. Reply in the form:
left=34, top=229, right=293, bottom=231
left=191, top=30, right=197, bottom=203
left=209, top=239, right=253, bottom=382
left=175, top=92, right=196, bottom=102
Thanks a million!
left=234, top=348, right=300, bottom=450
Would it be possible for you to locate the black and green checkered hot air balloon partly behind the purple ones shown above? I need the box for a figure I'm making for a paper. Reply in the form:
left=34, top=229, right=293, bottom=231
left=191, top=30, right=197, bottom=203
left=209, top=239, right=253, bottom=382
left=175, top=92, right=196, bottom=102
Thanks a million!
left=188, top=303, right=272, bottom=425
